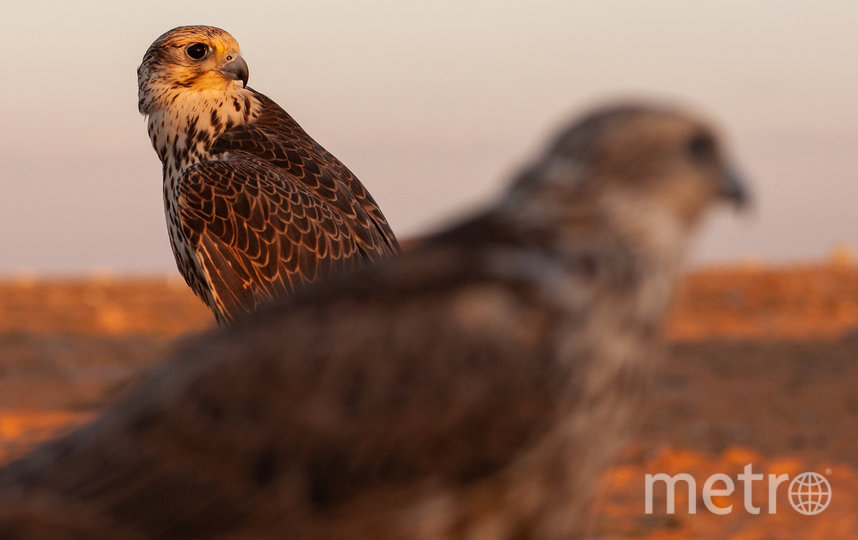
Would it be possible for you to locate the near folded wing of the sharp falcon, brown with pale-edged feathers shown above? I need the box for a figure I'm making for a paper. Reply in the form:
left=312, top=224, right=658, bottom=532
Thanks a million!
left=179, top=159, right=364, bottom=321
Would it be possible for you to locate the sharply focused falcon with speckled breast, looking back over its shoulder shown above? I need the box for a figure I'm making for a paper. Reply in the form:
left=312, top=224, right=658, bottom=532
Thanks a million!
left=137, top=26, right=399, bottom=324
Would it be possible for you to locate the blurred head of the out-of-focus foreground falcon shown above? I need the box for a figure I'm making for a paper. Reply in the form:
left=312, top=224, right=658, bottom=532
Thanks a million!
left=513, top=105, right=748, bottom=233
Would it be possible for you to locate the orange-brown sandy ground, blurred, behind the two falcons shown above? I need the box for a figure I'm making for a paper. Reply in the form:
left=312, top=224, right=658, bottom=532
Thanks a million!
left=0, top=262, right=858, bottom=540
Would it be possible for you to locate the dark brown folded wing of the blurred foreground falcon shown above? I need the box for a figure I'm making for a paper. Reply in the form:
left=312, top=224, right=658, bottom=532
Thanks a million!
left=0, top=246, right=566, bottom=538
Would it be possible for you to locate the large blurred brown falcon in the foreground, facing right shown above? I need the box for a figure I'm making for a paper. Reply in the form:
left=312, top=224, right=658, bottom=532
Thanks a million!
left=0, top=105, right=744, bottom=540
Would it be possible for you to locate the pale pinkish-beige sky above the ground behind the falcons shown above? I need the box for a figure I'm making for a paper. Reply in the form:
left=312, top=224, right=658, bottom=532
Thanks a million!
left=0, top=0, right=858, bottom=275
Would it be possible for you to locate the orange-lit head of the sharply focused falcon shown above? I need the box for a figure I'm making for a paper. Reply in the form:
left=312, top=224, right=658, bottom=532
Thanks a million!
left=137, top=26, right=248, bottom=114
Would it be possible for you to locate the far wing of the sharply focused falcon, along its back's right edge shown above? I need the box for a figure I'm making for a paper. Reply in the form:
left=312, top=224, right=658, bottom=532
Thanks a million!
left=211, top=92, right=400, bottom=255
